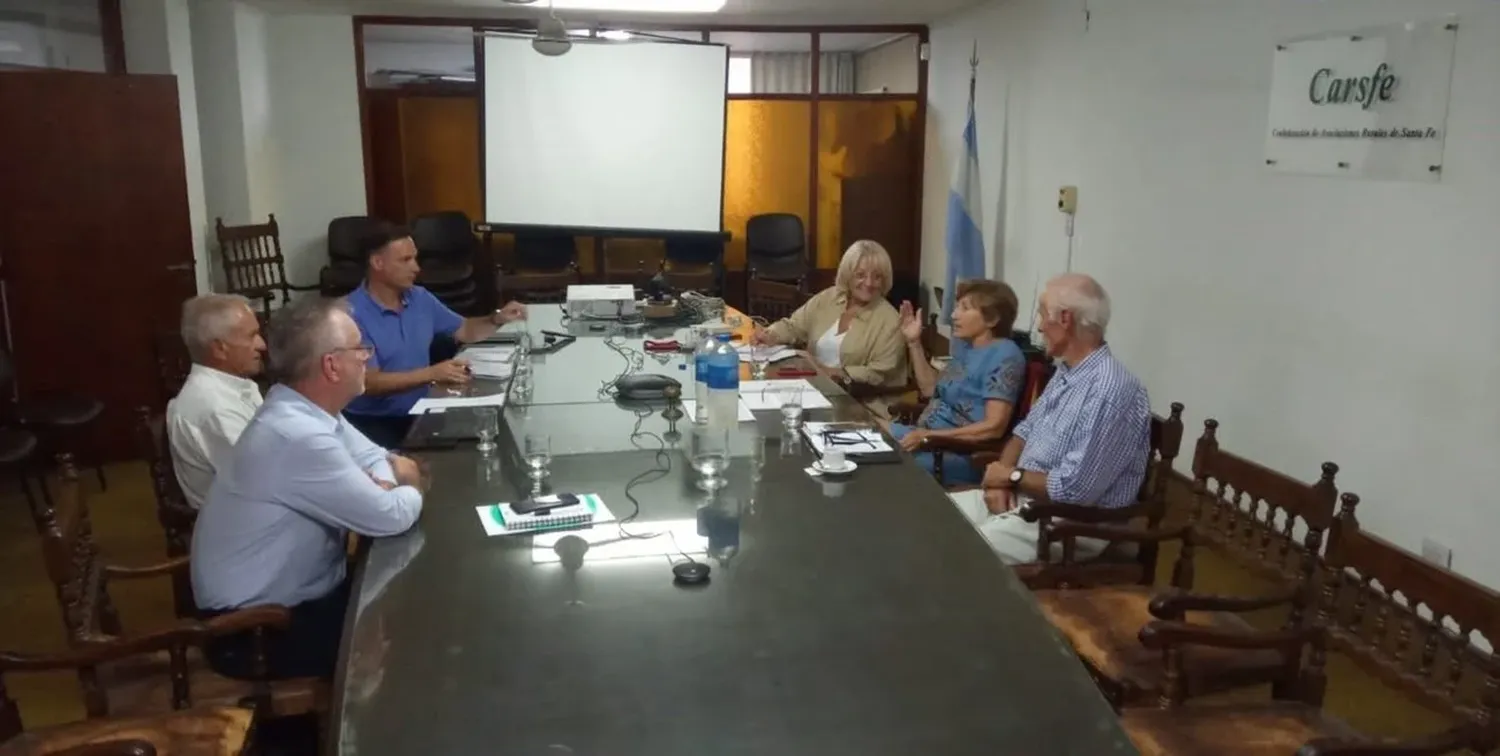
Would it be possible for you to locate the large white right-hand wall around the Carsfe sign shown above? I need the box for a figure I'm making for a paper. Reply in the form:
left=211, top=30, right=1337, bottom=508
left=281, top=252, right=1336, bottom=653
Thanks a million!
left=923, top=0, right=1500, bottom=585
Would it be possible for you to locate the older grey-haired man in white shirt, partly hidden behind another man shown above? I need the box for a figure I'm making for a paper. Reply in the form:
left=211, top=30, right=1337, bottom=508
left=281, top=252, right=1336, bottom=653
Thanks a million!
left=167, top=294, right=266, bottom=509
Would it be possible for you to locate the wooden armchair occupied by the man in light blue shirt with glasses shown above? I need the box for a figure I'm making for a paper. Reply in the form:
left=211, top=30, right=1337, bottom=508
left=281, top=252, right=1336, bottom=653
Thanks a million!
left=30, top=455, right=326, bottom=716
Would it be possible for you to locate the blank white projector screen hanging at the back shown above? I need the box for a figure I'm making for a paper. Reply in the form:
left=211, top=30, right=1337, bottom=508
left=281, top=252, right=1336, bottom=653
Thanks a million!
left=483, top=36, right=729, bottom=233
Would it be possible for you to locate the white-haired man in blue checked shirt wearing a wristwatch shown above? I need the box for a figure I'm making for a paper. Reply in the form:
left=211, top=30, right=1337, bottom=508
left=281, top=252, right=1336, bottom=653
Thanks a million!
left=980, top=273, right=1151, bottom=564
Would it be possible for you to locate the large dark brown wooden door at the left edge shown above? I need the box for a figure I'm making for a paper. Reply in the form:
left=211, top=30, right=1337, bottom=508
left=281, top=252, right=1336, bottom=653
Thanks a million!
left=0, top=71, right=197, bottom=459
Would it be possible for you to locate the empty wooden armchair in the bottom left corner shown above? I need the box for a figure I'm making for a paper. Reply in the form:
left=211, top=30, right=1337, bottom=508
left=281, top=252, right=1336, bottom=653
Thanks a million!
left=0, top=642, right=255, bottom=756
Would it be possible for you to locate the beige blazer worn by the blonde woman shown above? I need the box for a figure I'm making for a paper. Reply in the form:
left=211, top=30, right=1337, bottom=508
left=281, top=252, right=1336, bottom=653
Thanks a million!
left=767, top=287, right=909, bottom=387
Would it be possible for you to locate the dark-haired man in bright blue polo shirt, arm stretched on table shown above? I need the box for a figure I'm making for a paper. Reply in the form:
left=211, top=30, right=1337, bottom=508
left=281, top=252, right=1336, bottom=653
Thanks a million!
left=344, top=221, right=527, bottom=449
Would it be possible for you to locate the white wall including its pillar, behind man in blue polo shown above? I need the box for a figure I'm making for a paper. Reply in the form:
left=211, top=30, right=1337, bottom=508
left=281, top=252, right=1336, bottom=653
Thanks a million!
left=183, top=0, right=365, bottom=287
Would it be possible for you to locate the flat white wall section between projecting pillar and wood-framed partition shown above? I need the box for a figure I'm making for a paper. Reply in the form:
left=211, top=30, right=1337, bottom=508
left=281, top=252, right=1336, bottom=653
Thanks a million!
left=266, top=14, right=365, bottom=285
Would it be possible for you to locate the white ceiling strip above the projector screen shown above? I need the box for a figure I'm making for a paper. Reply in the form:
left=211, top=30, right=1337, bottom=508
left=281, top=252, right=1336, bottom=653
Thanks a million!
left=251, top=0, right=984, bottom=24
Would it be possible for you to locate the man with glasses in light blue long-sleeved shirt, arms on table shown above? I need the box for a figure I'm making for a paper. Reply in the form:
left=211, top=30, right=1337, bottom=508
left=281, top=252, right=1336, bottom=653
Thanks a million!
left=192, top=299, right=425, bottom=678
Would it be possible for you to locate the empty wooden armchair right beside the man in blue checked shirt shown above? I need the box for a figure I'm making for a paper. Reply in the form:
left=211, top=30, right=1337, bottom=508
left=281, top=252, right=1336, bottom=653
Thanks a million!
left=1037, top=429, right=1338, bottom=707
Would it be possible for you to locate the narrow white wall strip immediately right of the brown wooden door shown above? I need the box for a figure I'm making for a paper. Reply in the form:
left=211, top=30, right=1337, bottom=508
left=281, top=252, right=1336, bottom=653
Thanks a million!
left=120, top=0, right=212, bottom=291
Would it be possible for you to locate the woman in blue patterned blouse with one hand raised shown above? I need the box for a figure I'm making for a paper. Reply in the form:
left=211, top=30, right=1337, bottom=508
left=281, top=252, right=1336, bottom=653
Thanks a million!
left=891, top=281, right=1026, bottom=485
